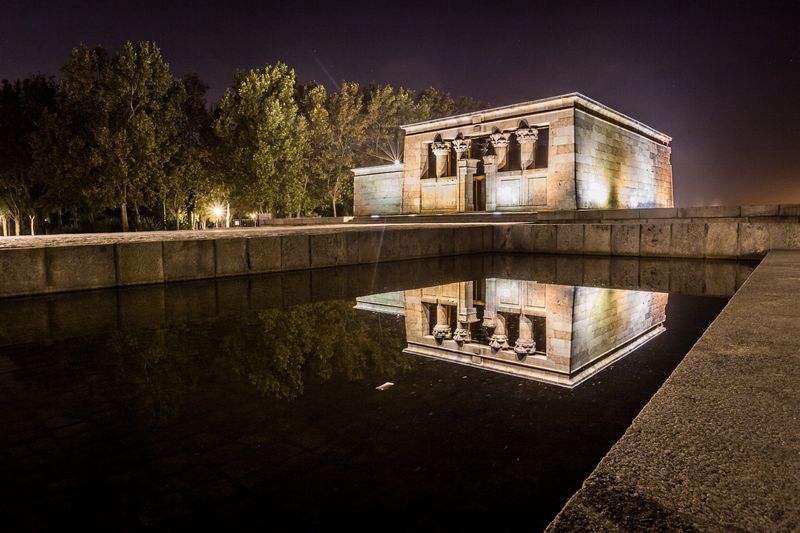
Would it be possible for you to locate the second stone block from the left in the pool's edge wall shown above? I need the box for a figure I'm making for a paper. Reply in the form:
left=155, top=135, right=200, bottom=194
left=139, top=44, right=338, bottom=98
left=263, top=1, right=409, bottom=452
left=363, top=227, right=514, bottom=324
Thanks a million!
left=46, top=244, right=117, bottom=291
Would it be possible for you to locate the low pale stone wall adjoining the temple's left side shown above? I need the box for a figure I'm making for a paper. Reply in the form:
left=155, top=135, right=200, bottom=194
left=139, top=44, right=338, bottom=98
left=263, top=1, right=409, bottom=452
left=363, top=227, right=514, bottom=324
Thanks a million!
left=353, top=165, right=403, bottom=216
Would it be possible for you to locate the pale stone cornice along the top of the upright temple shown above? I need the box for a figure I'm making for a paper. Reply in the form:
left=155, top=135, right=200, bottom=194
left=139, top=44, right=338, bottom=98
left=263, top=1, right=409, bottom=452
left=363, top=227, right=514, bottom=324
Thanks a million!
left=400, top=92, right=672, bottom=145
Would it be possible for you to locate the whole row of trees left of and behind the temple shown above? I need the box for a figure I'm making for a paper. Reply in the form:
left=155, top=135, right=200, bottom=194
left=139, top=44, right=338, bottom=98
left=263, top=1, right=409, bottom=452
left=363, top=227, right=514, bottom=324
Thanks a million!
left=0, top=42, right=485, bottom=235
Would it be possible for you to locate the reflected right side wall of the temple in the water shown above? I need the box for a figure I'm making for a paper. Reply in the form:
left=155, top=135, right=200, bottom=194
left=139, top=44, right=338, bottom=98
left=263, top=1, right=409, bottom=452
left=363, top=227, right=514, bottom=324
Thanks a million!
left=570, top=287, right=667, bottom=371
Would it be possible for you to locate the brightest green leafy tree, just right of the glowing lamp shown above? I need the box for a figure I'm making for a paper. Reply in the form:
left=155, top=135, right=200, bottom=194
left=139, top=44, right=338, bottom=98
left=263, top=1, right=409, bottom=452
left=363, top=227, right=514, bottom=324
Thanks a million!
left=214, top=63, right=306, bottom=215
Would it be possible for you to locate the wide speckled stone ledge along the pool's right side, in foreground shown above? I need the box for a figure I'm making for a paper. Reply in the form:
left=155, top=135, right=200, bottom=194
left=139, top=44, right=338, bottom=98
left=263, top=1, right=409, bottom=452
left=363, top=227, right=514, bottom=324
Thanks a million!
left=548, top=251, right=800, bottom=532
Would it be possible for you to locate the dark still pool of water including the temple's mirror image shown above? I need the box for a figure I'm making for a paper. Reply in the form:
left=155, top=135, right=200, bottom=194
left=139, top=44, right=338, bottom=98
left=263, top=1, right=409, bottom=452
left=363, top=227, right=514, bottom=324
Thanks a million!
left=0, top=256, right=752, bottom=531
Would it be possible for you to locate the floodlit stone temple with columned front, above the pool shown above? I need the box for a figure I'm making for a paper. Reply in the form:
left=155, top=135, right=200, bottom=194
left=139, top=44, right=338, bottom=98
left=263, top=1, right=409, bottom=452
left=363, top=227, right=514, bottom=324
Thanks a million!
left=353, top=93, right=673, bottom=216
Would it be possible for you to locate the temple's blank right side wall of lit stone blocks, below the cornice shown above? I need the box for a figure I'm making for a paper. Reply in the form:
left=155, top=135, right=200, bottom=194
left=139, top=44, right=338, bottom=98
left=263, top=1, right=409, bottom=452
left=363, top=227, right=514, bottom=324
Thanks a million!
left=575, top=109, right=673, bottom=209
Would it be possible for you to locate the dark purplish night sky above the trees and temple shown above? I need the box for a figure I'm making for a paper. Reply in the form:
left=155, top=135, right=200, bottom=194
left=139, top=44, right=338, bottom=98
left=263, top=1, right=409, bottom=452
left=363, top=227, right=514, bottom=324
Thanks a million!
left=0, top=0, right=800, bottom=206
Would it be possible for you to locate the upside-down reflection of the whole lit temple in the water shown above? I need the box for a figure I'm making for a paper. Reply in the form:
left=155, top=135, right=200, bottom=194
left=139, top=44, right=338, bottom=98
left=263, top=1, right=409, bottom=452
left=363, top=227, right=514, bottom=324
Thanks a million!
left=356, top=278, right=667, bottom=387
